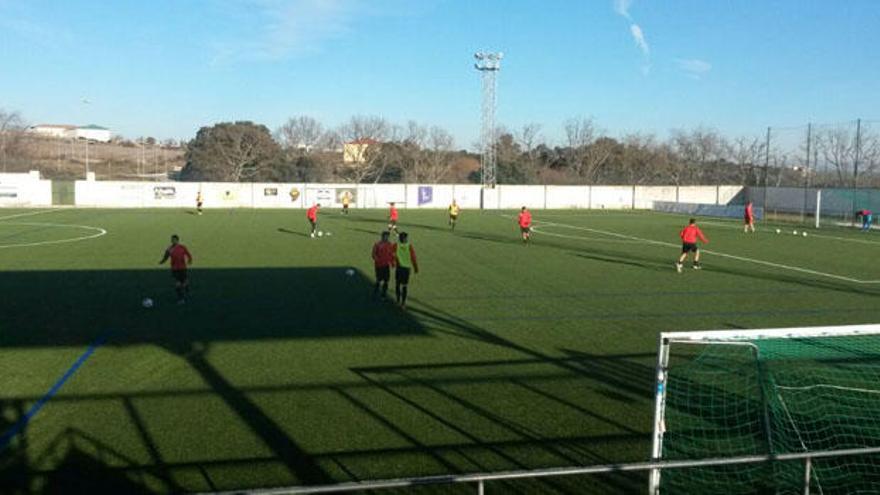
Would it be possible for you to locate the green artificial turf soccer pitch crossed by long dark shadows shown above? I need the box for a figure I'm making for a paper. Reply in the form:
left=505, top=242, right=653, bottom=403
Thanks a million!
left=0, top=209, right=880, bottom=493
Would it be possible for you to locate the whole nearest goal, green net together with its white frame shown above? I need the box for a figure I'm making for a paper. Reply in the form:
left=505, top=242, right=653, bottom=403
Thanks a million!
left=650, top=325, right=880, bottom=494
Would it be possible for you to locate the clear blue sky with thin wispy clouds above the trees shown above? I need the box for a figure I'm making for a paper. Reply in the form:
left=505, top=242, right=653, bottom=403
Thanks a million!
left=0, top=0, right=880, bottom=147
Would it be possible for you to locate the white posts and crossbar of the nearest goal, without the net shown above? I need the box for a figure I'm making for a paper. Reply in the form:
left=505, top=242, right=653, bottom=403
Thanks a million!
left=648, top=325, right=880, bottom=495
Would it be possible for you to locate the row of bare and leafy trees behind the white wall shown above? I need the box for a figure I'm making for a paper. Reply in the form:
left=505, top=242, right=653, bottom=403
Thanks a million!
left=0, top=109, right=880, bottom=187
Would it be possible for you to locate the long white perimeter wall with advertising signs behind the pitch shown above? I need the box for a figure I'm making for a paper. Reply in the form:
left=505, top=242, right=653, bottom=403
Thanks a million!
left=70, top=178, right=742, bottom=209
